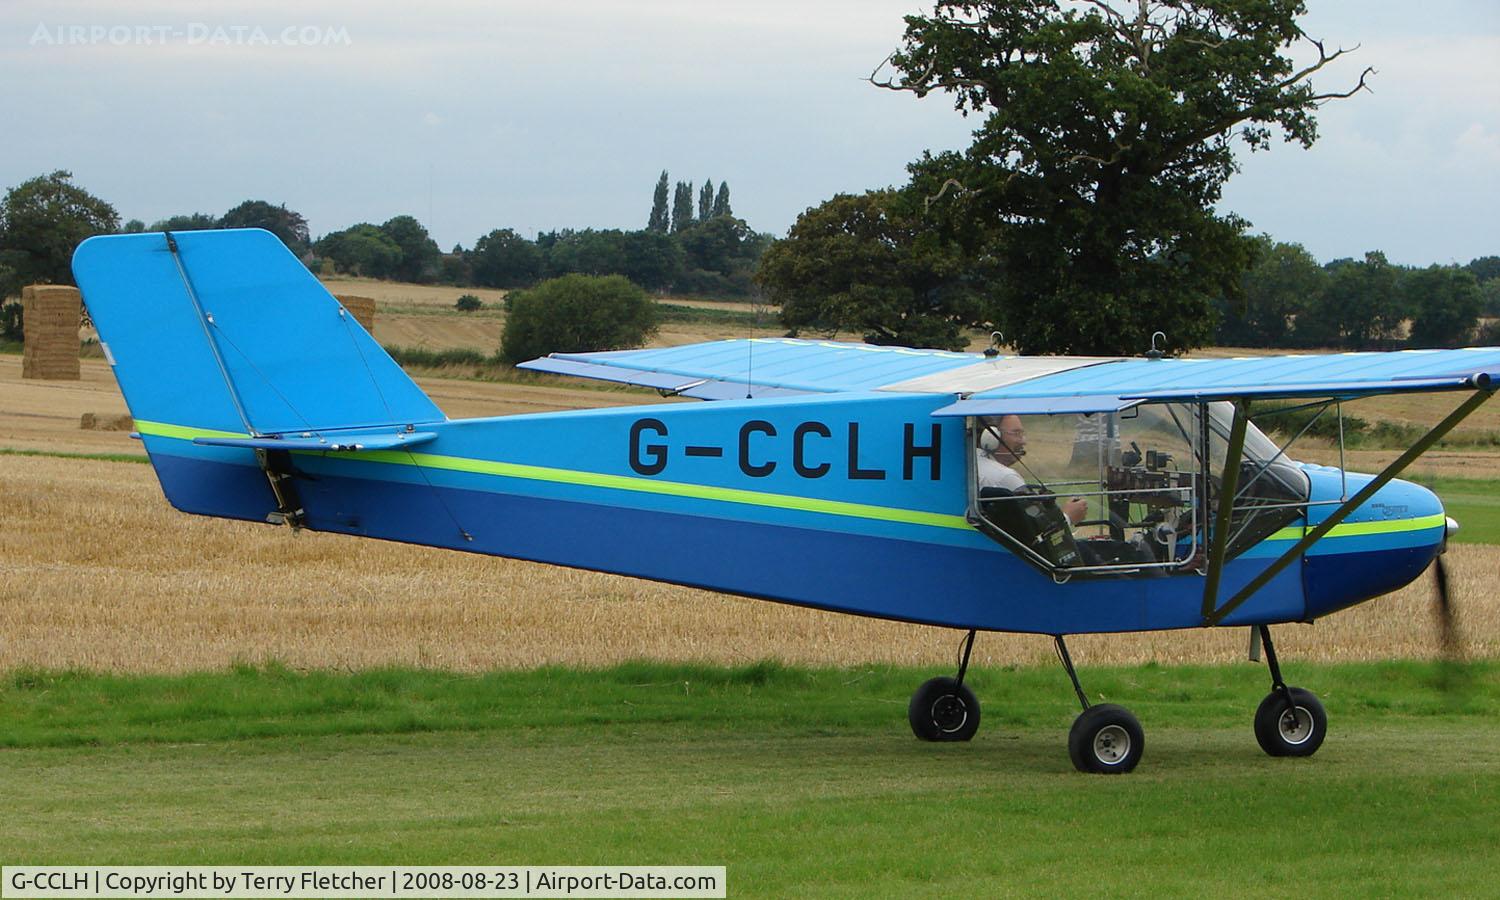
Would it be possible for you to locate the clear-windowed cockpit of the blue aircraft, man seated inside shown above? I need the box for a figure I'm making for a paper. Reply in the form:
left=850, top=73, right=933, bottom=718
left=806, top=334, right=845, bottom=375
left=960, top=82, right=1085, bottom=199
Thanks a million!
left=968, top=402, right=1310, bottom=578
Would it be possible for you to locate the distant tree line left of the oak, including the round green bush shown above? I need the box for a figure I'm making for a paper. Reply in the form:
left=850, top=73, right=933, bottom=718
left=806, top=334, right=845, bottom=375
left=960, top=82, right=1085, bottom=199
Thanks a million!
left=0, top=171, right=744, bottom=363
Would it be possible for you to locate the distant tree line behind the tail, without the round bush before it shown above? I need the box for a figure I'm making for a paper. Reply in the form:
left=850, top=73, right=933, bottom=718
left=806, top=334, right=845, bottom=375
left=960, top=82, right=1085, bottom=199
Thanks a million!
left=0, top=171, right=771, bottom=330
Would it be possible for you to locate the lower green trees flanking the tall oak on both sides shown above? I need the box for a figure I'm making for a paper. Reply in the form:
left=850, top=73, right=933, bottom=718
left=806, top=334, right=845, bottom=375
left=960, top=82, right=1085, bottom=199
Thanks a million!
left=758, top=189, right=1500, bottom=354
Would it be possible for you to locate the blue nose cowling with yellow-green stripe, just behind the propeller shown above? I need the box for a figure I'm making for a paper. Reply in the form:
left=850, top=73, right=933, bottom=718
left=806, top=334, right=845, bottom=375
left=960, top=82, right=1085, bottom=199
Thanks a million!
left=1302, top=470, right=1458, bottom=620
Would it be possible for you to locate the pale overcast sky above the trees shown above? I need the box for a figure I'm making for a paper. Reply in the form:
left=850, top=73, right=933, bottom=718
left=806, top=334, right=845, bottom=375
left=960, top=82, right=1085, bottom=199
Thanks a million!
left=0, top=0, right=1500, bottom=264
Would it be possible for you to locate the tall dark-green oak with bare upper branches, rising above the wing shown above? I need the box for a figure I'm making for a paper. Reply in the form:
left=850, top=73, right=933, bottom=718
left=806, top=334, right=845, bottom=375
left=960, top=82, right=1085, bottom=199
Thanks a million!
left=872, top=0, right=1368, bottom=354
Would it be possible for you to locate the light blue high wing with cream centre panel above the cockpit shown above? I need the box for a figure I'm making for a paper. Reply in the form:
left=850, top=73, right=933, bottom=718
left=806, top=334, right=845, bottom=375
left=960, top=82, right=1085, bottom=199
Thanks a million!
left=522, top=339, right=1500, bottom=405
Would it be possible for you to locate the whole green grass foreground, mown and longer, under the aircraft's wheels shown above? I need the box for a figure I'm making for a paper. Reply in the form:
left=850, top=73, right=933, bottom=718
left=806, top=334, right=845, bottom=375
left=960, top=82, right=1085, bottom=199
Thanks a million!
left=0, top=662, right=1500, bottom=897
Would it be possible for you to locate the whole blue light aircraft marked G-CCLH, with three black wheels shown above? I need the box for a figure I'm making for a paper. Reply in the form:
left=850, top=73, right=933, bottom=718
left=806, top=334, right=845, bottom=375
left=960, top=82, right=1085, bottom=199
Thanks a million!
left=74, top=230, right=1500, bottom=773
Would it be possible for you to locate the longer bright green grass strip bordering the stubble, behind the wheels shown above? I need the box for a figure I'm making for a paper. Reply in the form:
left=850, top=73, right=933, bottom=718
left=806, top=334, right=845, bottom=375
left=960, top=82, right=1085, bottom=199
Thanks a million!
left=0, top=660, right=1500, bottom=750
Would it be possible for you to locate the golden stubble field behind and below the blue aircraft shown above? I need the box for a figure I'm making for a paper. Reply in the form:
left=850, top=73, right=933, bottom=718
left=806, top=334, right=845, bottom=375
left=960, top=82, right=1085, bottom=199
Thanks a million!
left=0, top=357, right=1500, bottom=672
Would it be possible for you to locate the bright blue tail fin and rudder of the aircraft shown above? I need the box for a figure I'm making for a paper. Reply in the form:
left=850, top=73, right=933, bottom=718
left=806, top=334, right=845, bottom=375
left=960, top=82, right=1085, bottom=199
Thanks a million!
left=74, top=230, right=444, bottom=519
